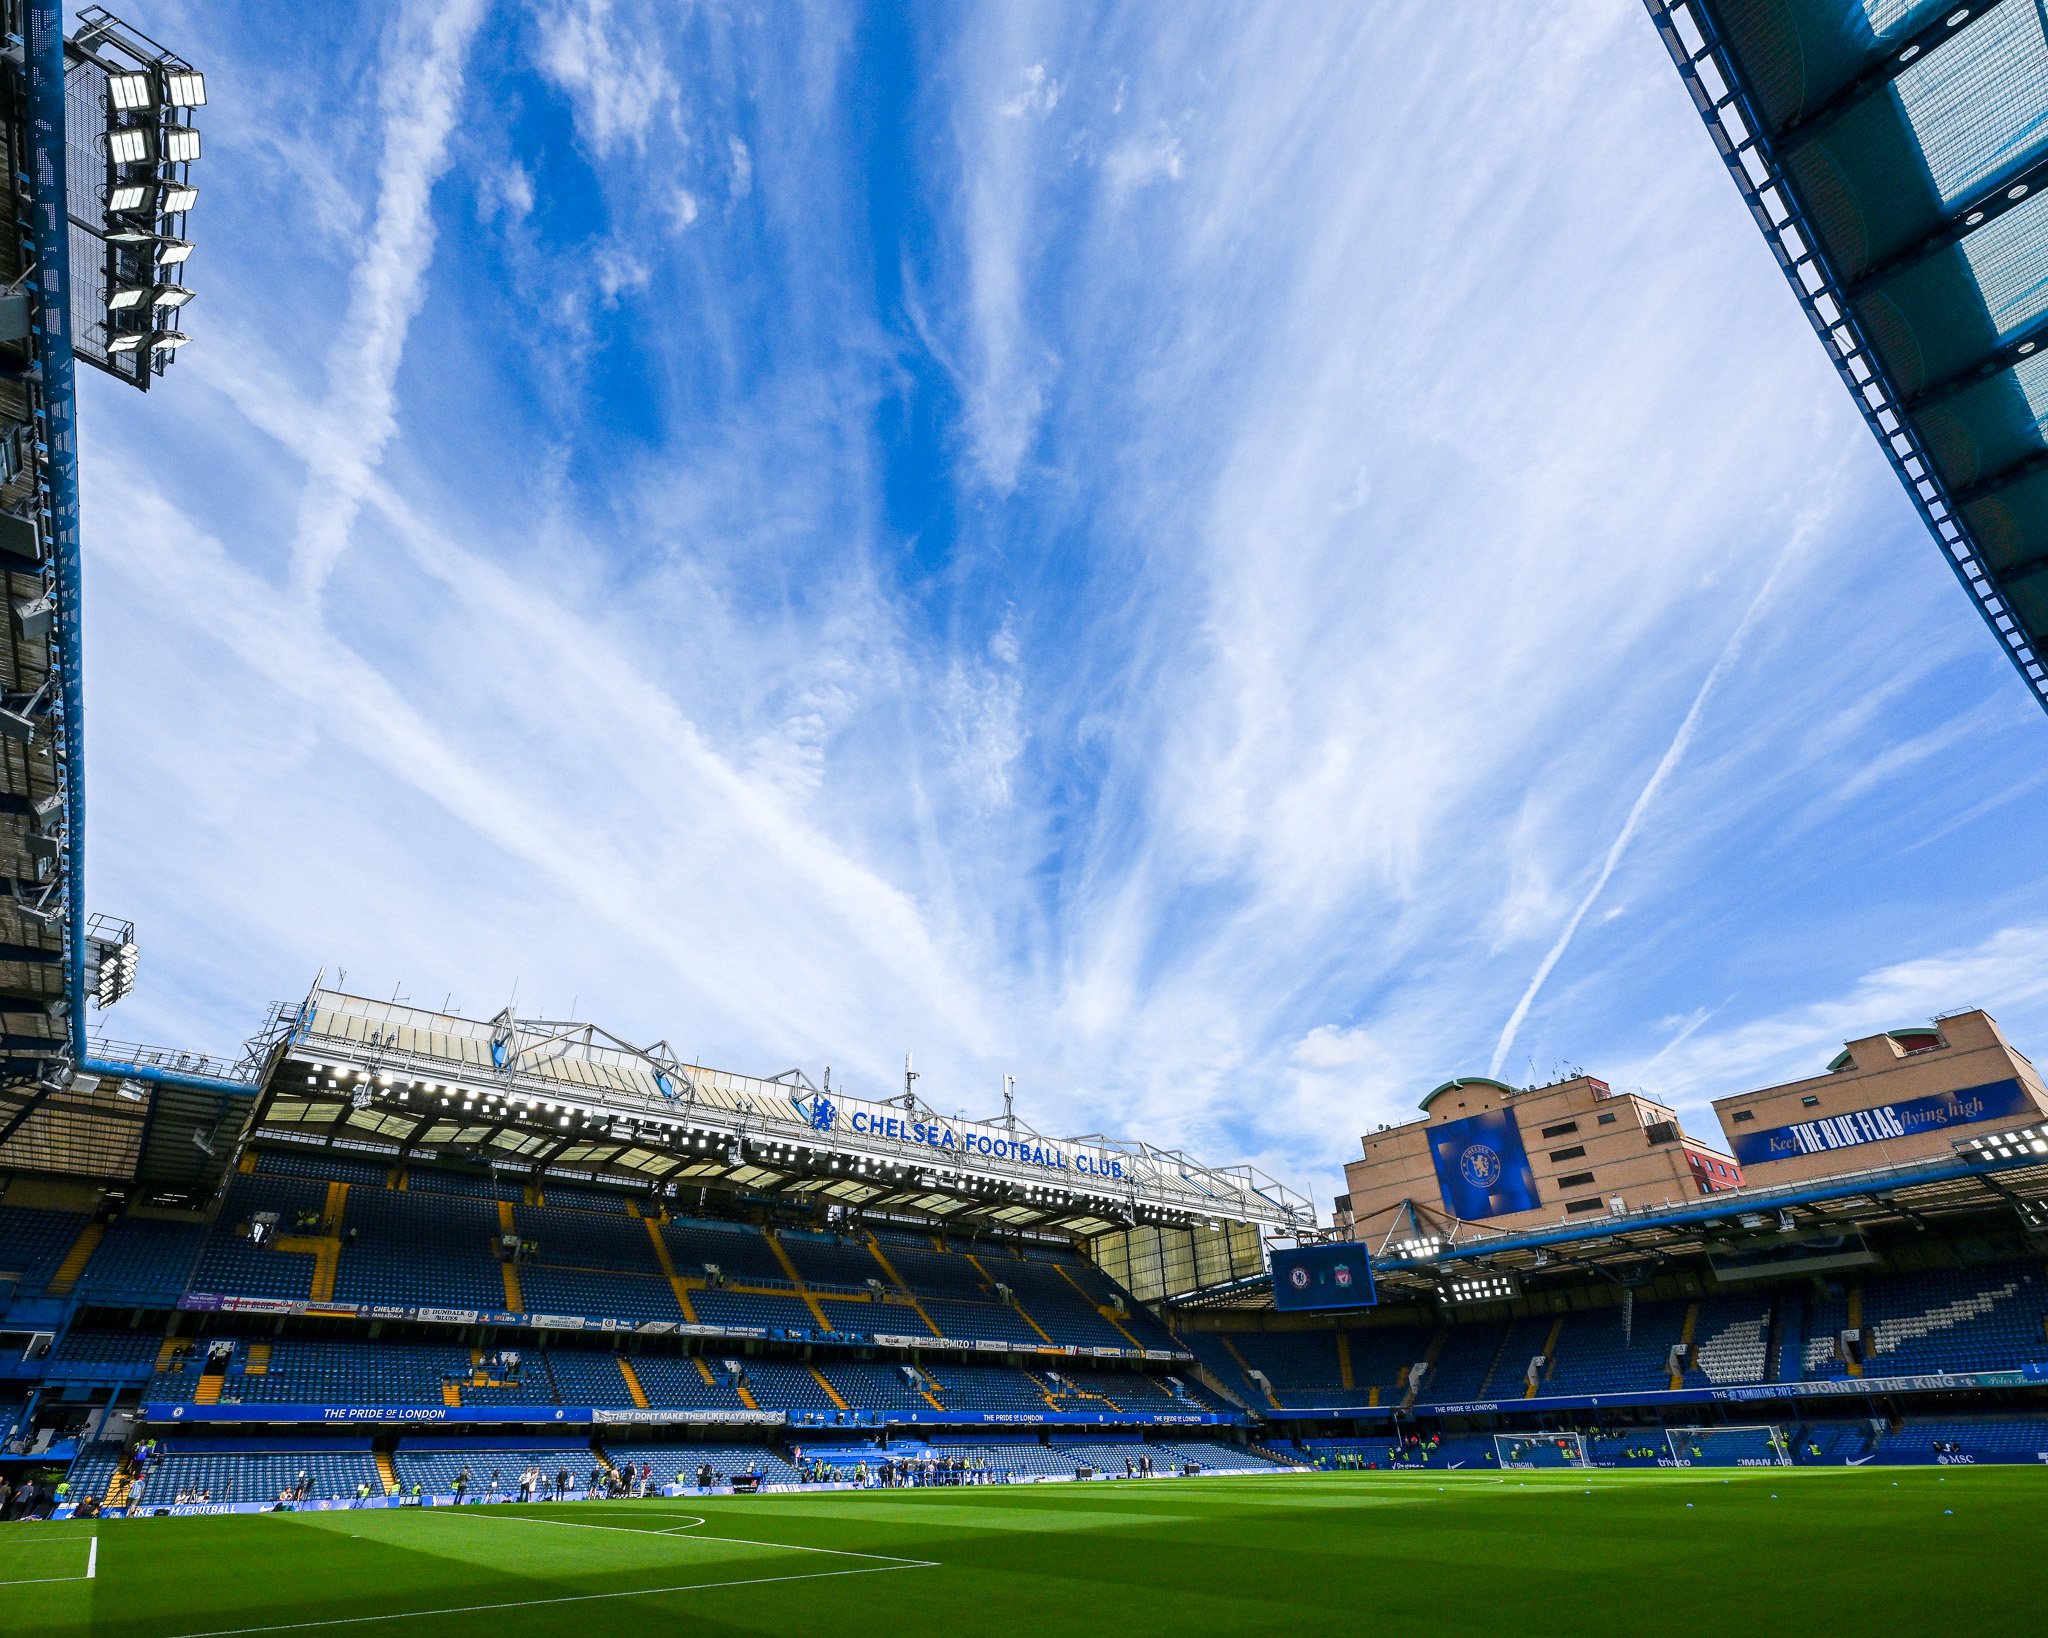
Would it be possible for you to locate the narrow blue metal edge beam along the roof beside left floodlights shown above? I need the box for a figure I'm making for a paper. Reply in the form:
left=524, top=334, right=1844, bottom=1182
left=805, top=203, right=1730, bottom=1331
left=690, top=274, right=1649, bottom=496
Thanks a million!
left=27, top=0, right=256, bottom=1097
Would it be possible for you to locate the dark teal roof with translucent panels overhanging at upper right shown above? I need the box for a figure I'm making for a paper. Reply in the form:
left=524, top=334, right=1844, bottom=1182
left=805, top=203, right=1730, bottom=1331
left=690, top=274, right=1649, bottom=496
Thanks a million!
left=1645, top=0, right=2048, bottom=706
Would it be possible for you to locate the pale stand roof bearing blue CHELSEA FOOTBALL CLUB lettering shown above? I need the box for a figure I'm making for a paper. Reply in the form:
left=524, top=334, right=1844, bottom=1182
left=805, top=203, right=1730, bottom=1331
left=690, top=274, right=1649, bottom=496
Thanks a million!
left=229, top=985, right=1315, bottom=1235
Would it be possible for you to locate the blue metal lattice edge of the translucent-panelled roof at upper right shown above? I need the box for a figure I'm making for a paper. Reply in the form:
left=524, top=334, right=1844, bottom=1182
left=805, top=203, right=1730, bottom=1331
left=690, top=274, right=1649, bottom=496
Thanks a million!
left=1642, top=0, right=2048, bottom=710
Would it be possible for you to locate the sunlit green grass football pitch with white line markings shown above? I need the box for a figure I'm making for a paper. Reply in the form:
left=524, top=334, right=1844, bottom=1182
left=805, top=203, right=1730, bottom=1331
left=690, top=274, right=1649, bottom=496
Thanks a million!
left=0, top=1468, right=2048, bottom=1638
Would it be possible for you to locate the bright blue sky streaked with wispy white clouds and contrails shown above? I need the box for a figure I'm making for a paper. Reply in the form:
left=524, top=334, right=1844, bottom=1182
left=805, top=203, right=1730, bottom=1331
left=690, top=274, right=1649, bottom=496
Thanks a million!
left=68, top=0, right=2048, bottom=1208
